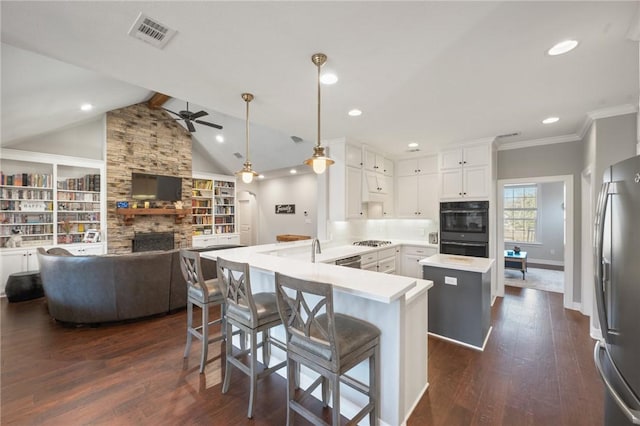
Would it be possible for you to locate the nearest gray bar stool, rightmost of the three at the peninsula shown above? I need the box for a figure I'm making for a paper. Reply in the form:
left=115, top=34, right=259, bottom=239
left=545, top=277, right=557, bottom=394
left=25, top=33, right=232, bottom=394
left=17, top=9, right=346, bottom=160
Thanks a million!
left=275, top=272, right=380, bottom=425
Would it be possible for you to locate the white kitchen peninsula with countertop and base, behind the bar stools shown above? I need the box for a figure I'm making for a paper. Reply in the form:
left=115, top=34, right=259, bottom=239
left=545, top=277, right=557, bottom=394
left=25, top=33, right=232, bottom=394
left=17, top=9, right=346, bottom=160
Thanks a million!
left=201, top=241, right=432, bottom=425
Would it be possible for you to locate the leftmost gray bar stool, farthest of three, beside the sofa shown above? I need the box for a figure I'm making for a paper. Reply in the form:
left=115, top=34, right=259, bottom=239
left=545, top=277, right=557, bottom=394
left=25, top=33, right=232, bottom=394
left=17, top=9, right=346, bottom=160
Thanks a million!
left=180, top=250, right=225, bottom=373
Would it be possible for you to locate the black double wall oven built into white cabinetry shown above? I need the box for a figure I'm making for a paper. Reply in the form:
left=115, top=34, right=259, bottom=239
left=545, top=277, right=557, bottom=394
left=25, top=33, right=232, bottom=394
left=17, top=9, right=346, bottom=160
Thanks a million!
left=440, top=201, right=489, bottom=257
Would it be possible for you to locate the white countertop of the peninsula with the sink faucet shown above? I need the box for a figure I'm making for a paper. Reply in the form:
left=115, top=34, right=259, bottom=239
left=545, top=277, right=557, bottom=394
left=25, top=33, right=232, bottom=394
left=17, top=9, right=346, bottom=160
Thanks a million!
left=200, top=240, right=436, bottom=303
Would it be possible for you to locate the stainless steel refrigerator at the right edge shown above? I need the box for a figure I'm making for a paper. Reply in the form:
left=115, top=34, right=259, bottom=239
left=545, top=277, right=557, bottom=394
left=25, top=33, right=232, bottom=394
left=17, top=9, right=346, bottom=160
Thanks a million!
left=594, top=156, right=640, bottom=426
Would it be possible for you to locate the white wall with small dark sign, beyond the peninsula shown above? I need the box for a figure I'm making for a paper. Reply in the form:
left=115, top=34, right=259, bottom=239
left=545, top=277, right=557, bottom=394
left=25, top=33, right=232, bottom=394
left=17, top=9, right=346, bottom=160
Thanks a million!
left=256, top=173, right=318, bottom=244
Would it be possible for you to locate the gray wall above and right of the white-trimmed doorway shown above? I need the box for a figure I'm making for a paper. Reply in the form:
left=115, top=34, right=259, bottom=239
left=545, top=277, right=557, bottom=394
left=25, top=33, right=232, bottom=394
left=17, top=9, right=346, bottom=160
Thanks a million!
left=498, top=141, right=584, bottom=303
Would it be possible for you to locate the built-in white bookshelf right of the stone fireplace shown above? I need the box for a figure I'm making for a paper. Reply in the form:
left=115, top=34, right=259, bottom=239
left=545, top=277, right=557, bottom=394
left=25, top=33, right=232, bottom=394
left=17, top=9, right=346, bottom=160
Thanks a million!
left=191, top=176, right=237, bottom=236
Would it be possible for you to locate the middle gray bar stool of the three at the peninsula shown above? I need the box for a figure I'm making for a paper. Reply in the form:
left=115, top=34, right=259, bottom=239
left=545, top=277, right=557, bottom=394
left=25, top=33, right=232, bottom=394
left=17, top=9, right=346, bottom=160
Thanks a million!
left=217, top=257, right=286, bottom=418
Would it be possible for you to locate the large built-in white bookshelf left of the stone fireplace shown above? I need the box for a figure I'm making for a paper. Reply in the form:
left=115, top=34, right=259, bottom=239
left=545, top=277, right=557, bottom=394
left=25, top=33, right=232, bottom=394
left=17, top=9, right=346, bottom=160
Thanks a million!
left=0, top=150, right=104, bottom=248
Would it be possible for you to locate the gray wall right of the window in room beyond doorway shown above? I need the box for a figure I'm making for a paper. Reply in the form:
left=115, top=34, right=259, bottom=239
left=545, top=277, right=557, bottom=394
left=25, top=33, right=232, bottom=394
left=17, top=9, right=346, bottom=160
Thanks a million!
left=504, top=182, right=564, bottom=265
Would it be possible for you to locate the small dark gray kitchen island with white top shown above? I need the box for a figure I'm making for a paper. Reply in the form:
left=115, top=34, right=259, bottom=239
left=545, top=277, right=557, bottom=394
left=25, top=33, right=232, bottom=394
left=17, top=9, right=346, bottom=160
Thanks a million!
left=420, top=254, right=494, bottom=350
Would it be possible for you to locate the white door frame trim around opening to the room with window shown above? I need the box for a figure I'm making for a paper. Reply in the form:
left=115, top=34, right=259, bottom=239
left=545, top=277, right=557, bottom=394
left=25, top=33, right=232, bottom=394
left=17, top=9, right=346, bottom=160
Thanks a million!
left=496, top=175, right=576, bottom=309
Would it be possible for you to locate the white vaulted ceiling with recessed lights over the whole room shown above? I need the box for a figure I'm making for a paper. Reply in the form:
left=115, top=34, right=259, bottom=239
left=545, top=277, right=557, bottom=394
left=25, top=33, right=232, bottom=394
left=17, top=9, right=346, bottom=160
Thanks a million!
left=1, top=1, right=639, bottom=176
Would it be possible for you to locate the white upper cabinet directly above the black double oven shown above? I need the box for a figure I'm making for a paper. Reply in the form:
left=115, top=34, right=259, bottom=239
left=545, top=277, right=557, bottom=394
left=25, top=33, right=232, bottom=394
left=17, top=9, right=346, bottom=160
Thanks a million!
left=439, top=143, right=491, bottom=200
